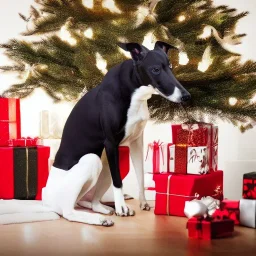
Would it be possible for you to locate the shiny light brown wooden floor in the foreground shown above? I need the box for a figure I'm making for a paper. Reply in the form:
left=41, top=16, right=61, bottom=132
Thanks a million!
left=0, top=200, right=256, bottom=256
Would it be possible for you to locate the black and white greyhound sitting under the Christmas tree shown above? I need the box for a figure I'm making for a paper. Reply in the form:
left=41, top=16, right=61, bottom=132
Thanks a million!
left=43, top=41, right=191, bottom=226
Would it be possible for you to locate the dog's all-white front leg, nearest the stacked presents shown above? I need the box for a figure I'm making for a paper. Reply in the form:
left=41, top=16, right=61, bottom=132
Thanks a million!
left=130, top=133, right=150, bottom=211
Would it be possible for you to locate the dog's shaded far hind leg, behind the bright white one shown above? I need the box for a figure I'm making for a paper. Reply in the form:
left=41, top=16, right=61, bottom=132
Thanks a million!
left=77, top=151, right=115, bottom=214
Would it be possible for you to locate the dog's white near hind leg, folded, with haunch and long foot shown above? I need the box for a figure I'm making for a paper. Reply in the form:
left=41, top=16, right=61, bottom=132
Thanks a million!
left=42, top=154, right=113, bottom=226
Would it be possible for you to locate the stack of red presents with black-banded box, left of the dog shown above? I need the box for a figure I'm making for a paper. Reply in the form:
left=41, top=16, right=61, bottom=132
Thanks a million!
left=0, top=98, right=50, bottom=200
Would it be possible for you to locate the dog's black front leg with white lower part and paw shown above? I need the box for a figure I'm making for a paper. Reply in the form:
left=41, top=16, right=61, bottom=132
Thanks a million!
left=105, top=140, right=135, bottom=216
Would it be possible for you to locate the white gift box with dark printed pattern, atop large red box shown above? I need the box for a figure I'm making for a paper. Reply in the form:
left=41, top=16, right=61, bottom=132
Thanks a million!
left=187, top=146, right=209, bottom=175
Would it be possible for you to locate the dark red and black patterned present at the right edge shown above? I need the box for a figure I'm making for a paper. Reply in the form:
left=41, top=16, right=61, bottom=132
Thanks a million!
left=243, top=172, right=256, bottom=199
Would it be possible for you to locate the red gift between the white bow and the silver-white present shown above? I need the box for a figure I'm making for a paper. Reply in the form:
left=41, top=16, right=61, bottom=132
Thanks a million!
left=213, top=199, right=240, bottom=225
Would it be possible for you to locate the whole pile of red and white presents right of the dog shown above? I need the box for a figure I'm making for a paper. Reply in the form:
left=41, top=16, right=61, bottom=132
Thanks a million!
left=144, top=123, right=256, bottom=239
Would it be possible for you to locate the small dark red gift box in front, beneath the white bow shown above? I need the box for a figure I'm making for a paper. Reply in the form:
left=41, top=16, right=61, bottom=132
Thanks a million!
left=187, top=218, right=234, bottom=240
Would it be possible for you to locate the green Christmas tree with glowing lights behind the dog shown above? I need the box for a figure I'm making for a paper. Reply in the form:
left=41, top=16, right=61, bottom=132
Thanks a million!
left=1, top=0, right=256, bottom=128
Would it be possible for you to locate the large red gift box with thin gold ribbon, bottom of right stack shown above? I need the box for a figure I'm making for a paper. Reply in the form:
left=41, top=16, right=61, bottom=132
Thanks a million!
left=154, top=171, right=223, bottom=216
